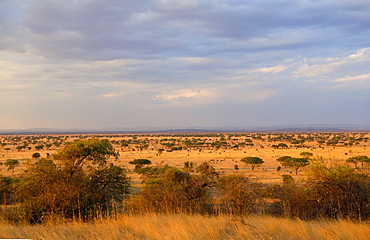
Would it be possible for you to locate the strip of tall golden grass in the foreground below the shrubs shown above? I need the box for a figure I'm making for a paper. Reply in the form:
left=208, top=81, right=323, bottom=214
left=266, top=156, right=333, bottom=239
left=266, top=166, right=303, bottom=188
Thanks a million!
left=0, top=214, right=370, bottom=240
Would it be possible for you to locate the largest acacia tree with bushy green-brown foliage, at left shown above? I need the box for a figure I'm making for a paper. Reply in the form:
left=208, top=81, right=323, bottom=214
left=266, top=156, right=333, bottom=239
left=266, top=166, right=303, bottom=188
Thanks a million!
left=17, top=138, right=130, bottom=222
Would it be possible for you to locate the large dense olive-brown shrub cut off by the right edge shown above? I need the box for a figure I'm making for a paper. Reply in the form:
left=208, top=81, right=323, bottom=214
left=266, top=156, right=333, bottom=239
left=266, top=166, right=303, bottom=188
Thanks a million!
left=307, top=165, right=370, bottom=220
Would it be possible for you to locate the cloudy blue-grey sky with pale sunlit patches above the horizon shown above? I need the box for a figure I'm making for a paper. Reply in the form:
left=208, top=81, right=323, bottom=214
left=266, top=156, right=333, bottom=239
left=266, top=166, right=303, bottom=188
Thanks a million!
left=0, top=0, right=370, bottom=129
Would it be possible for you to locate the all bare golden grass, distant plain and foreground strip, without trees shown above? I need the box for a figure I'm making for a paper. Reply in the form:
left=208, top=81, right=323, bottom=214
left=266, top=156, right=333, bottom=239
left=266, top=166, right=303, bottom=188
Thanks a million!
left=0, top=133, right=370, bottom=240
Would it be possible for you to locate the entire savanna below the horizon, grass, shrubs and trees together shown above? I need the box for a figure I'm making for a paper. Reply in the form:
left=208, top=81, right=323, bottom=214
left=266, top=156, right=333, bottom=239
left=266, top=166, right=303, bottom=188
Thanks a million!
left=0, top=132, right=370, bottom=239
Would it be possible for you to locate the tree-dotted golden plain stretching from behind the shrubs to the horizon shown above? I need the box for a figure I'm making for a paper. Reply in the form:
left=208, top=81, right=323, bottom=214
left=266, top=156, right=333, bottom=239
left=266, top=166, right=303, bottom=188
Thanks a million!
left=0, top=132, right=370, bottom=186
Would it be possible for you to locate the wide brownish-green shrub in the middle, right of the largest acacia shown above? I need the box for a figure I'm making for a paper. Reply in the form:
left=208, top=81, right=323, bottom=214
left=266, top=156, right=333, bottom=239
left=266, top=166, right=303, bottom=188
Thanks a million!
left=127, top=166, right=212, bottom=213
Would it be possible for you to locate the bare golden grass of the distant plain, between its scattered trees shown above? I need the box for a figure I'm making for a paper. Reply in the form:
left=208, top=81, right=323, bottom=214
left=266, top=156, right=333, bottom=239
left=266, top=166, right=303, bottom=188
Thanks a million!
left=0, top=133, right=370, bottom=185
